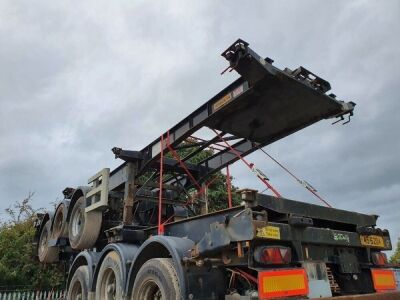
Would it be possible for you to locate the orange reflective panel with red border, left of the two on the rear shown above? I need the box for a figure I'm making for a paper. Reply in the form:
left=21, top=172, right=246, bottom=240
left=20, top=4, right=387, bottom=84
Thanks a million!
left=258, top=269, right=308, bottom=299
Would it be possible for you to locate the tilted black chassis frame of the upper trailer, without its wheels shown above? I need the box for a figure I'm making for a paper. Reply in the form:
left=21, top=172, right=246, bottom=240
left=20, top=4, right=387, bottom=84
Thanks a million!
left=86, top=39, right=355, bottom=232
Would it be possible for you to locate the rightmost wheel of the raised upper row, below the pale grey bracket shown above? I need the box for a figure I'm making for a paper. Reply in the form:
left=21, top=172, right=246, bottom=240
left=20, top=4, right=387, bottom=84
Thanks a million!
left=68, top=197, right=102, bottom=249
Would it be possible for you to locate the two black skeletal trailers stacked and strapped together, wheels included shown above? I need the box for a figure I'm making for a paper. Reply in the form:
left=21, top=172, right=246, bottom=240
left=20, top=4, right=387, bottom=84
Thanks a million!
left=36, top=39, right=400, bottom=300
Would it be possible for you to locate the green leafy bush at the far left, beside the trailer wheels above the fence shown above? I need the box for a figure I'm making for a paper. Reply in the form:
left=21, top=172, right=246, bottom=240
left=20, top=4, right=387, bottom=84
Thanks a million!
left=0, top=193, right=64, bottom=290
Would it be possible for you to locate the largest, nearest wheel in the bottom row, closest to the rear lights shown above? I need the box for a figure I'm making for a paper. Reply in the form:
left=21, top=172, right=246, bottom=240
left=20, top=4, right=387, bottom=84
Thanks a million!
left=131, top=258, right=183, bottom=300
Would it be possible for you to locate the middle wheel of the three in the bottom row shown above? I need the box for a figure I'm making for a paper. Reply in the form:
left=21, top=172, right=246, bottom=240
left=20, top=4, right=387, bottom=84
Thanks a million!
left=96, top=251, right=124, bottom=300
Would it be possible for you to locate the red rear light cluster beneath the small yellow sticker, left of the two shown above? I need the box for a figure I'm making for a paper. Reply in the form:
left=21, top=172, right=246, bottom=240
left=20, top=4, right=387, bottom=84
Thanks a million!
left=254, top=246, right=292, bottom=265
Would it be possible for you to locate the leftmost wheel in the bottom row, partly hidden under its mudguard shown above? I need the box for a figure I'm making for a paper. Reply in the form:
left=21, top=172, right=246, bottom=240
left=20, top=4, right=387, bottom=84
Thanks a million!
left=67, top=266, right=89, bottom=300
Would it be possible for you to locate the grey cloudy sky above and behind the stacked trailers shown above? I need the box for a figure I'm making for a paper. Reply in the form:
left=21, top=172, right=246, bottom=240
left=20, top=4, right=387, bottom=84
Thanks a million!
left=0, top=0, right=400, bottom=252
